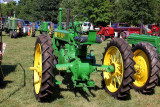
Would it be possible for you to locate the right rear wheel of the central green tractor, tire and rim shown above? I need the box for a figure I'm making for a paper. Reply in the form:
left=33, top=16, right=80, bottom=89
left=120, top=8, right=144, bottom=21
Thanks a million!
left=102, top=38, right=135, bottom=99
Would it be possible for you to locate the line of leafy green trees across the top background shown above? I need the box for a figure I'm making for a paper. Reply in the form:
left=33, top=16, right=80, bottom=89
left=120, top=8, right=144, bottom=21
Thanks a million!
left=1, top=0, right=160, bottom=26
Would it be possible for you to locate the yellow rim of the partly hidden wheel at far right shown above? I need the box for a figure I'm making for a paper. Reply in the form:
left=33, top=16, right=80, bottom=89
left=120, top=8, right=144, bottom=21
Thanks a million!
left=133, top=49, right=149, bottom=87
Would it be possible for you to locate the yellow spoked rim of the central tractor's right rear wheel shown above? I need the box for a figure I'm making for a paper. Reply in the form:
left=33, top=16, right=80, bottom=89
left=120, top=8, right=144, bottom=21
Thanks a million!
left=103, top=46, right=124, bottom=92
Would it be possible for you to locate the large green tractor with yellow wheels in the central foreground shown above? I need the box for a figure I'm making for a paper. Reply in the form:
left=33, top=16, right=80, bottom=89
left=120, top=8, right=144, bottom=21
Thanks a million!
left=30, top=8, right=158, bottom=102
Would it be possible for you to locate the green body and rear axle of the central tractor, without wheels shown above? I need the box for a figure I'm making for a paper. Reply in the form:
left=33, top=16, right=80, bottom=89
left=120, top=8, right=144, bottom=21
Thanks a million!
left=53, top=8, right=114, bottom=92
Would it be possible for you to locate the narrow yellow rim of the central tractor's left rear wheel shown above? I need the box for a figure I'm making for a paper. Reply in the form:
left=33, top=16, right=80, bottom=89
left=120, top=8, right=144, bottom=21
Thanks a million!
left=34, top=43, right=42, bottom=94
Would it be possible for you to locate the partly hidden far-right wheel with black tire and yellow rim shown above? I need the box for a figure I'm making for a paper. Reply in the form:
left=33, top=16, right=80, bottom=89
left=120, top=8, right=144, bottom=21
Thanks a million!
left=132, top=42, right=159, bottom=94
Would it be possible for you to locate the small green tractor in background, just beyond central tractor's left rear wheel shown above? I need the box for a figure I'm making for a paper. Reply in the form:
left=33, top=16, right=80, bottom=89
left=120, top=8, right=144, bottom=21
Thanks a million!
left=30, top=21, right=54, bottom=38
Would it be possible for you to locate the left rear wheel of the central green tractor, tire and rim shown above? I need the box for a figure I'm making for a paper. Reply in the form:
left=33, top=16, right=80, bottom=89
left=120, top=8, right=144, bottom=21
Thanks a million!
left=33, top=34, right=55, bottom=102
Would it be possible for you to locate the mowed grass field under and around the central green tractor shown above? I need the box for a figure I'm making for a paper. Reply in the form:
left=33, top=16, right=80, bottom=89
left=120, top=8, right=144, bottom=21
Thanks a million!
left=0, top=33, right=160, bottom=107
